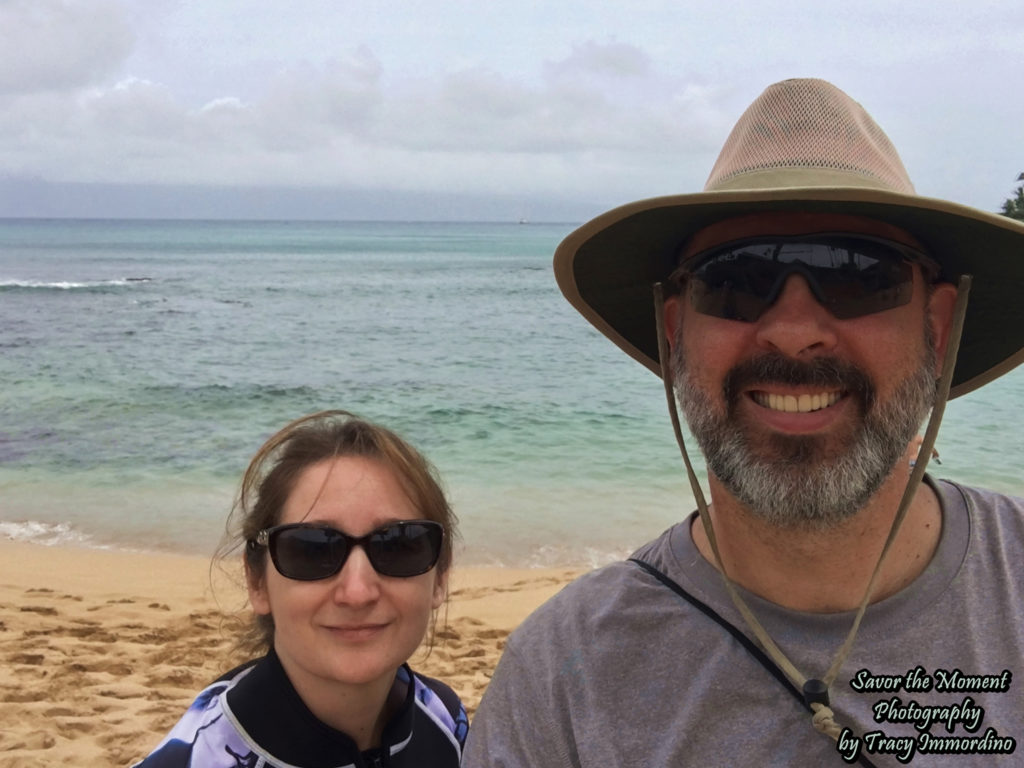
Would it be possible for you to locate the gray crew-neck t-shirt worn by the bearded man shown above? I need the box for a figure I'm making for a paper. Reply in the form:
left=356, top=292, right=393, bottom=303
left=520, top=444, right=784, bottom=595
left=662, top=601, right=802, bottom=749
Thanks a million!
left=463, top=482, right=1024, bottom=768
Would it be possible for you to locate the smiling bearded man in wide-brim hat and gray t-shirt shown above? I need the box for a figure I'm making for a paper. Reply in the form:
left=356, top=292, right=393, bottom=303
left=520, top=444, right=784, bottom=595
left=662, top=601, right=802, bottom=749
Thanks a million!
left=464, top=80, right=1024, bottom=768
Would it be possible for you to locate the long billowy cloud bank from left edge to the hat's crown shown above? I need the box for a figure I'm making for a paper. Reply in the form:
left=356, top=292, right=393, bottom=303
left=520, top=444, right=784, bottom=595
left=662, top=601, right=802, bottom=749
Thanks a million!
left=0, top=36, right=725, bottom=198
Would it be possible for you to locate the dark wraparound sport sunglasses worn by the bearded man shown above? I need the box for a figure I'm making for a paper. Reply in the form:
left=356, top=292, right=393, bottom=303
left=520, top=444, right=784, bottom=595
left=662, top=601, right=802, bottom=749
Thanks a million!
left=673, top=232, right=938, bottom=323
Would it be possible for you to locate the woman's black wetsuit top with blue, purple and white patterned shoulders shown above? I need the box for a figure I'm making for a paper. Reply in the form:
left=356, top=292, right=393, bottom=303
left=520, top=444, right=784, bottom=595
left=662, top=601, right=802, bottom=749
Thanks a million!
left=135, top=650, right=469, bottom=768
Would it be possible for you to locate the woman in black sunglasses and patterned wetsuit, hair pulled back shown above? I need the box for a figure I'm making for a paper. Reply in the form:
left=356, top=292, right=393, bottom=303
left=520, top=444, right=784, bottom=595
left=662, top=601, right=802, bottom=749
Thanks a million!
left=137, top=411, right=468, bottom=768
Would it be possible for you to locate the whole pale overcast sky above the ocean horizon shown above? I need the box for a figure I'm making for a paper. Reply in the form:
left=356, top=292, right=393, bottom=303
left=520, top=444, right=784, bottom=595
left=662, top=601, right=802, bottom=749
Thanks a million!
left=0, top=0, right=1024, bottom=221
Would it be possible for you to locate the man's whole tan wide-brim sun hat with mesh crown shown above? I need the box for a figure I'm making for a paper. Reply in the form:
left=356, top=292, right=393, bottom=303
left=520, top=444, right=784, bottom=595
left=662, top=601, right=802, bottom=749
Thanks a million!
left=554, top=79, right=1024, bottom=398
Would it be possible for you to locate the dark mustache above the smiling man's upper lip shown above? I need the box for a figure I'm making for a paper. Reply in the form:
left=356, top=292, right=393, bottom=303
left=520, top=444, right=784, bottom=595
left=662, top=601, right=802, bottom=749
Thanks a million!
left=722, top=353, right=874, bottom=412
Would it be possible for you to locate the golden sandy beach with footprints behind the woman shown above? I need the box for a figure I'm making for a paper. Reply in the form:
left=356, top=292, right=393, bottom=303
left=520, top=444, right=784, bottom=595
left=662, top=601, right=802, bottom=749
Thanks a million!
left=0, top=541, right=575, bottom=768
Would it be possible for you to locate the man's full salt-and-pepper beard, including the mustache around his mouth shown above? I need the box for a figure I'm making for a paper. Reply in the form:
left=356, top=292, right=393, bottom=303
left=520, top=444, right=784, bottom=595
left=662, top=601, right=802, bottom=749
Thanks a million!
left=671, top=324, right=935, bottom=530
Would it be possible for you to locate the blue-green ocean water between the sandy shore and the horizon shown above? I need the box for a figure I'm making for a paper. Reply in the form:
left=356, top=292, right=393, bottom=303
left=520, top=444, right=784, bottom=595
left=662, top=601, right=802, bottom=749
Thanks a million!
left=0, top=220, right=1024, bottom=567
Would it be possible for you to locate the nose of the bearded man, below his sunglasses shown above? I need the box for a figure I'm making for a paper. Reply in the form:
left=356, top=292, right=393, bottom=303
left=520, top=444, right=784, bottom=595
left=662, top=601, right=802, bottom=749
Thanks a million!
left=757, top=274, right=838, bottom=357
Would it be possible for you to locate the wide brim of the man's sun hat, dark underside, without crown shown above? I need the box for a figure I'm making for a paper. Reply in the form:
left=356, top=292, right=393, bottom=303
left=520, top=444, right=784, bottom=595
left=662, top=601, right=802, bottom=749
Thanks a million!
left=554, top=187, right=1024, bottom=398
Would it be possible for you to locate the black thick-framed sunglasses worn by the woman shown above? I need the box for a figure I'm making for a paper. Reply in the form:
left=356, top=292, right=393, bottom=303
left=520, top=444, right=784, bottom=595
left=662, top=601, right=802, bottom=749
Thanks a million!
left=248, top=520, right=444, bottom=582
